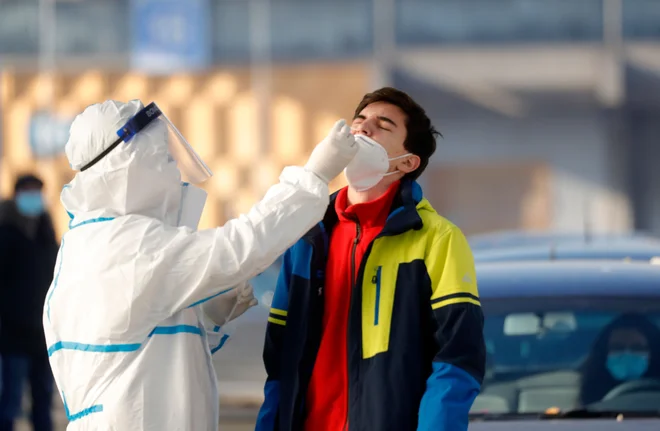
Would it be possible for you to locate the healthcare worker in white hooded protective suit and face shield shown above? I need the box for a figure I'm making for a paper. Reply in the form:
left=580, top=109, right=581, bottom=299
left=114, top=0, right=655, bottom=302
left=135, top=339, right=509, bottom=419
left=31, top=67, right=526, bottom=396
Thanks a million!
left=43, top=101, right=357, bottom=431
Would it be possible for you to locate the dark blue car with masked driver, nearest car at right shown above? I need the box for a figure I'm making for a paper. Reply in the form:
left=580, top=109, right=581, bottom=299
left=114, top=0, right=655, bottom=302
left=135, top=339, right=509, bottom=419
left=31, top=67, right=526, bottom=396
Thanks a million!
left=470, top=261, right=660, bottom=430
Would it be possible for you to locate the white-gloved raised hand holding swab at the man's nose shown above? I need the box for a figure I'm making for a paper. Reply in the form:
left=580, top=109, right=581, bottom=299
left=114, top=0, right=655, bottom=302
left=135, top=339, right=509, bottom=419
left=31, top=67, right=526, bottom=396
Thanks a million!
left=305, top=120, right=358, bottom=184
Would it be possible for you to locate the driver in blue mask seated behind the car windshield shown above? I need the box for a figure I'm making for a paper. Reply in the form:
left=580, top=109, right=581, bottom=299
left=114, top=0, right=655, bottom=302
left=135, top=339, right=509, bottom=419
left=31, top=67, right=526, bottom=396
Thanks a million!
left=580, top=313, right=660, bottom=406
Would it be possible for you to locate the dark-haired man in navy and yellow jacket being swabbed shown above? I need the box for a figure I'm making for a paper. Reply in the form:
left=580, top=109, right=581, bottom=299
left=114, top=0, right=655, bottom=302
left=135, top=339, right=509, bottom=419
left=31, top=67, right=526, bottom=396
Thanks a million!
left=256, top=88, right=486, bottom=431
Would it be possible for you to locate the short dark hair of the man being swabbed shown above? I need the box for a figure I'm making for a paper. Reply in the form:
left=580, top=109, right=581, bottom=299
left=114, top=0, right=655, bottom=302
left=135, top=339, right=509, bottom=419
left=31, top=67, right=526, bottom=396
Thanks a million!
left=353, top=87, right=442, bottom=180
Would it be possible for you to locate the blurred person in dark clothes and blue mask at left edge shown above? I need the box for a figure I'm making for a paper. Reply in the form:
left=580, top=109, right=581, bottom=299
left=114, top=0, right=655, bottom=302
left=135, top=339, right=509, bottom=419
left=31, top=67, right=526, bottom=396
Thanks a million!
left=0, top=175, right=58, bottom=431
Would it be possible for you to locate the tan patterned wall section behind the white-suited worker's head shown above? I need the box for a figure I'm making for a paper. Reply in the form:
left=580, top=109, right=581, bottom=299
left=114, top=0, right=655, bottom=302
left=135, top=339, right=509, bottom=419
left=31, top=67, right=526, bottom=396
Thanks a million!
left=0, top=63, right=367, bottom=238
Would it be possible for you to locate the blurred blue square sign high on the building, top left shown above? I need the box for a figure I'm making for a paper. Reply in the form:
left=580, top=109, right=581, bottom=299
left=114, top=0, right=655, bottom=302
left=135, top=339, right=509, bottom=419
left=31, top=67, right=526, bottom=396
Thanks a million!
left=131, top=0, right=211, bottom=73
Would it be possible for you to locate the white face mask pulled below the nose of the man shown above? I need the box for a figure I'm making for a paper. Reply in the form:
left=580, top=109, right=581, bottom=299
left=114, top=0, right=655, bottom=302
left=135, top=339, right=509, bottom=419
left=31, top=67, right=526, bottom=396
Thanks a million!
left=344, top=135, right=412, bottom=192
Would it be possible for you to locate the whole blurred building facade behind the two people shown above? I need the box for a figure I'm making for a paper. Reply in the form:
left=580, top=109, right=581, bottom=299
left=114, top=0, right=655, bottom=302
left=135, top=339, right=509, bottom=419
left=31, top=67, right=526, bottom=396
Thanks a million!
left=0, top=0, right=660, bottom=240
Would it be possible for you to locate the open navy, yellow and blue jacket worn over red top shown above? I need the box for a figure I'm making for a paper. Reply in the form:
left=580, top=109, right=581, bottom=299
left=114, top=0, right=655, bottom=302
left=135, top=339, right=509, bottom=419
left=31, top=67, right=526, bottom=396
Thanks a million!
left=256, top=181, right=486, bottom=431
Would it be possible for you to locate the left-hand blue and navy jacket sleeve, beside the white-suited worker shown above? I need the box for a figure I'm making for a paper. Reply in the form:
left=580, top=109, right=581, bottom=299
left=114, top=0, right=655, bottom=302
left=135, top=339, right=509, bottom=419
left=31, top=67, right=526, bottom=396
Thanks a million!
left=255, top=250, right=295, bottom=431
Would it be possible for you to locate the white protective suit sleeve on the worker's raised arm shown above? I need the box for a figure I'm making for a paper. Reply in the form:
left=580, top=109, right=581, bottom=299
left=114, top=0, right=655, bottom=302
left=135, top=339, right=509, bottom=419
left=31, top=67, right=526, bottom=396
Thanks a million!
left=102, top=167, right=328, bottom=329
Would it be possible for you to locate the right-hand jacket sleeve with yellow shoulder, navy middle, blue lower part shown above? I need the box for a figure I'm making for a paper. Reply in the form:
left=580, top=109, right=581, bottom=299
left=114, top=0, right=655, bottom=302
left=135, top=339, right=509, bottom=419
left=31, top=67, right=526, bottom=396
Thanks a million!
left=418, top=227, right=486, bottom=431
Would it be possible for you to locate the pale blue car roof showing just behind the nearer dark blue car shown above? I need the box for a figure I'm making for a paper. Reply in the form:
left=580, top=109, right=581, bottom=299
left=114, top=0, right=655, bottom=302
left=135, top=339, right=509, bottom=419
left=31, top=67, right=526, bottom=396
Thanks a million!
left=474, top=240, right=660, bottom=263
